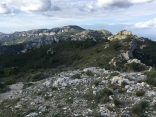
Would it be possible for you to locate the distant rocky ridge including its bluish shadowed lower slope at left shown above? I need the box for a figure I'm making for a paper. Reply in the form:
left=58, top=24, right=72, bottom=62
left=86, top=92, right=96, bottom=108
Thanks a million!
left=0, top=25, right=112, bottom=55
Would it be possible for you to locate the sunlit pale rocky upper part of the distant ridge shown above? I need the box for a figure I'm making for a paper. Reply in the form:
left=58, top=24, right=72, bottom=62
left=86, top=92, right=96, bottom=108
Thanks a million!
left=0, top=25, right=112, bottom=46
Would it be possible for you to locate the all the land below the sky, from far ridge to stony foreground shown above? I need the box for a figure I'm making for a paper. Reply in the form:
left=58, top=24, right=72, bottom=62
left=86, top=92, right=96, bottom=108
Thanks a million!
left=0, top=26, right=156, bottom=117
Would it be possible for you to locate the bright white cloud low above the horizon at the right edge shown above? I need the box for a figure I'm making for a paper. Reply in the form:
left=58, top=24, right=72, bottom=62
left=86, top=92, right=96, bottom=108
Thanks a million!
left=132, top=18, right=156, bottom=28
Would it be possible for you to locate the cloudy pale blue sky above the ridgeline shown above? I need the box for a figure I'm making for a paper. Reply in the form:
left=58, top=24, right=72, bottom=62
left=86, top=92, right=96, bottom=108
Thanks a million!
left=0, top=0, right=156, bottom=40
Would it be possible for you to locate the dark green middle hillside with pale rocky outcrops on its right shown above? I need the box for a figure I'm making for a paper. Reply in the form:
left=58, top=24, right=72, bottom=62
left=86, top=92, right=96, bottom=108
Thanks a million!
left=0, top=28, right=156, bottom=82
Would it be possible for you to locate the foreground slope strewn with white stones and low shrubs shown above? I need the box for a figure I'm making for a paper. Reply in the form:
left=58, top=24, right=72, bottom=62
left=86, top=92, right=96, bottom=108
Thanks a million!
left=0, top=67, right=156, bottom=117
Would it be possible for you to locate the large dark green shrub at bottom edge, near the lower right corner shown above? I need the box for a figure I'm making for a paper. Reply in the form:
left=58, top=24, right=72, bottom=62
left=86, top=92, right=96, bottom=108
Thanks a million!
left=131, top=100, right=149, bottom=117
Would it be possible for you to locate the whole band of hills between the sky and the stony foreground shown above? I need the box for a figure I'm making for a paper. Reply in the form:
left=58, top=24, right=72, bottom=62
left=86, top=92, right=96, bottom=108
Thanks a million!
left=0, top=26, right=156, bottom=74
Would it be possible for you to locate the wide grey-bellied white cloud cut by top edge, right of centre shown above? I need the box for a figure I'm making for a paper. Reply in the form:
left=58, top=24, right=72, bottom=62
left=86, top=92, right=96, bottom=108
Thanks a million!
left=97, top=0, right=156, bottom=8
